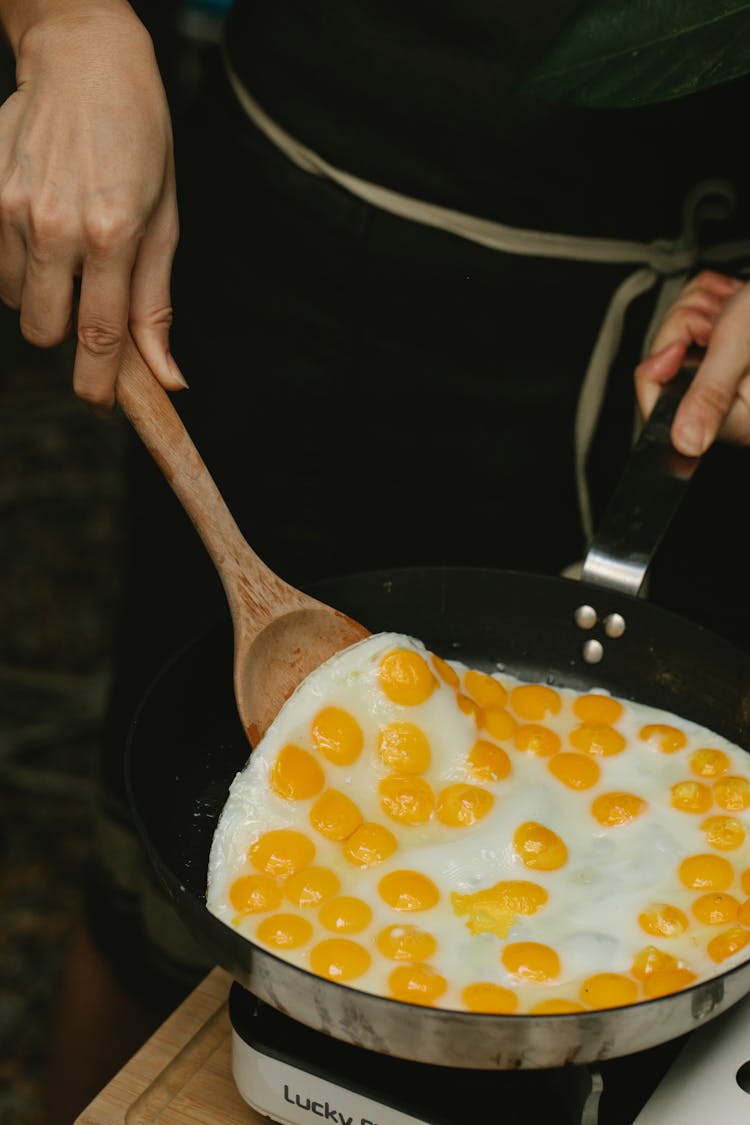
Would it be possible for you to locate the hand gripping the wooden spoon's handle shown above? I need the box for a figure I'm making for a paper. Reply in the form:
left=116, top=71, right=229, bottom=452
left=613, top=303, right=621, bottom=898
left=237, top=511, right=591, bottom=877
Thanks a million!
left=0, top=0, right=186, bottom=411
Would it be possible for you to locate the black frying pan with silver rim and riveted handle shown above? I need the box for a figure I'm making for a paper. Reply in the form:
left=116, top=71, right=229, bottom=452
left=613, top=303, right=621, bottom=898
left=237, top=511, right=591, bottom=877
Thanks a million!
left=126, top=366, right=750, bottom=1070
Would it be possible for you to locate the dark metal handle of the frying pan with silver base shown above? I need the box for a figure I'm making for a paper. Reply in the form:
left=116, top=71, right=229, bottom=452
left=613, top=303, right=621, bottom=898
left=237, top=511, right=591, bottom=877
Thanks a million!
left=580, top=349, right=703, bottom=596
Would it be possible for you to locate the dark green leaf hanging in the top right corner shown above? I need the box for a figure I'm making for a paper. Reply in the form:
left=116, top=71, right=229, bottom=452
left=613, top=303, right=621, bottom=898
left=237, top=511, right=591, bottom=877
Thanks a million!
left=521, top=0, right=750, bottom=107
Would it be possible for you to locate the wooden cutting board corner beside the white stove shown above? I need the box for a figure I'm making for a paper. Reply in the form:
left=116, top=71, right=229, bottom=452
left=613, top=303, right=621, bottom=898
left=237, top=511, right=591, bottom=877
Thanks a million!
left=75, top=969, right=270, bottom=1125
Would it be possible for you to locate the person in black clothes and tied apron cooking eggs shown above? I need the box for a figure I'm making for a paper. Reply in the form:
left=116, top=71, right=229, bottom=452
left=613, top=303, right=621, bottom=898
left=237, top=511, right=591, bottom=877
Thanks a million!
left=0, top=0, right=750, bottom=1123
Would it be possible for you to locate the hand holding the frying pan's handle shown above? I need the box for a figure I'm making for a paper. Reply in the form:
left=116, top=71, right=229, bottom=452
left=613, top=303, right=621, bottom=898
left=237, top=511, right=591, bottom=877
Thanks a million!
left=635, top=270, right=750, bottom=457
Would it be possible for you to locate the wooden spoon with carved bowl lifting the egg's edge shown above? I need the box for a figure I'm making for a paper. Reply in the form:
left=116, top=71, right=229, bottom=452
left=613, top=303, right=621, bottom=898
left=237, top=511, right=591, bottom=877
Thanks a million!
left=116, top=340, right=369, bottom=746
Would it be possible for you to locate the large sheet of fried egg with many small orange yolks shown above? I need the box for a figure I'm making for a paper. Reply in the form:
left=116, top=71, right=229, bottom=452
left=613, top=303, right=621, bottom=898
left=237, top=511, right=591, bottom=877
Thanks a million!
left=207, top=633, right=750, bottom=1014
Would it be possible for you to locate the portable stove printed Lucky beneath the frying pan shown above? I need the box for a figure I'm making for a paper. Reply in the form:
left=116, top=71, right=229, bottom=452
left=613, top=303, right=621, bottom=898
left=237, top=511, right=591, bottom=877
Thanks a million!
left=229, top=983, right=750, bottom=1125
